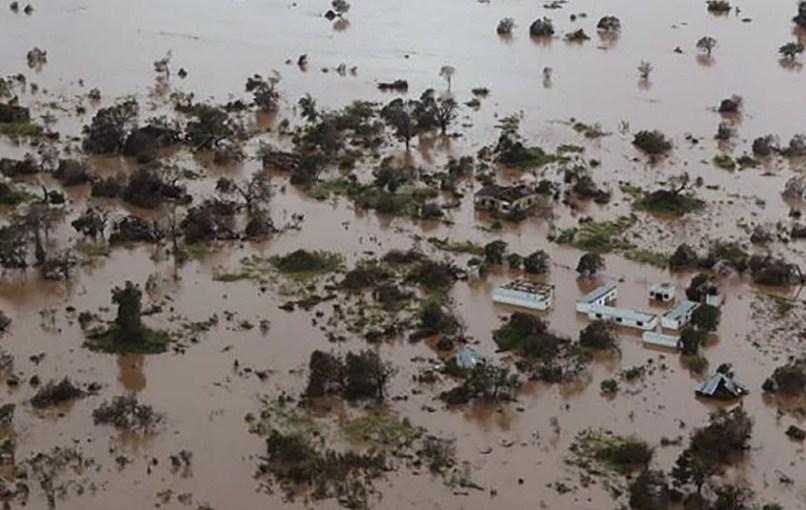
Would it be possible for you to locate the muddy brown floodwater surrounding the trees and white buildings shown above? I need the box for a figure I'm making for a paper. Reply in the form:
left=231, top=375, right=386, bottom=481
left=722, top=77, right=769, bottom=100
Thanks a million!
left=0, top=0, right=806, bottom=510
